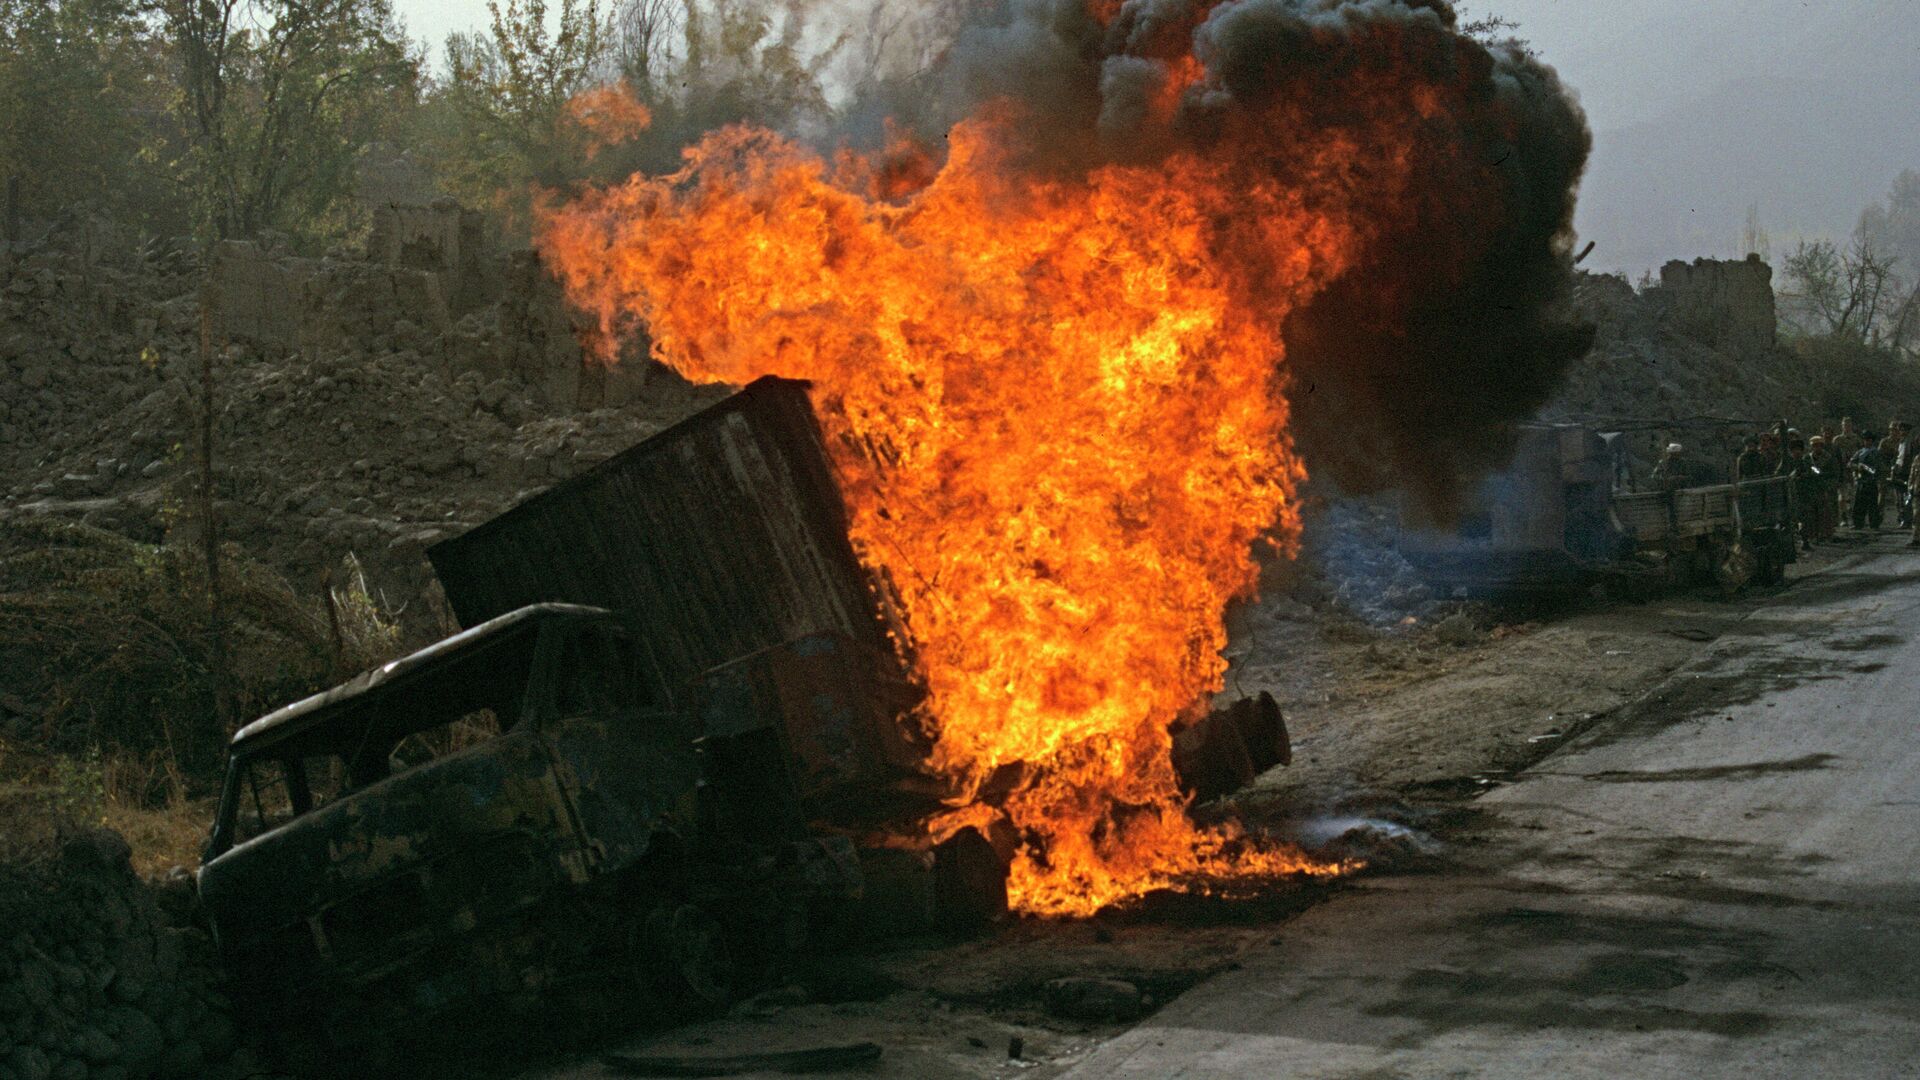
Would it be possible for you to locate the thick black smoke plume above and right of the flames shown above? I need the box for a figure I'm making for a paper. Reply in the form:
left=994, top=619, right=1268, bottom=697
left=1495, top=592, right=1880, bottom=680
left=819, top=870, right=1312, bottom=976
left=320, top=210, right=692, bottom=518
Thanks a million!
left=931, top=0, right=1592, bottom=517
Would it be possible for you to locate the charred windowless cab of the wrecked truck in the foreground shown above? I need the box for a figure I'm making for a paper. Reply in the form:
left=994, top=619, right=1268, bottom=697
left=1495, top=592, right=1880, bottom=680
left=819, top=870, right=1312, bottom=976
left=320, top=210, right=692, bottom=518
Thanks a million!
left=200, top=603, right=858, bottom=1036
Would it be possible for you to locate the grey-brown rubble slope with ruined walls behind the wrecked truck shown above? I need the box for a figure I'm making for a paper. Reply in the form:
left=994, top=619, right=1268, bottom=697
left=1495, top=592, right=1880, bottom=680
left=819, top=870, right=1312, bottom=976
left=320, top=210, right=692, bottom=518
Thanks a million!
left=0, top=206, right=716, bottom=632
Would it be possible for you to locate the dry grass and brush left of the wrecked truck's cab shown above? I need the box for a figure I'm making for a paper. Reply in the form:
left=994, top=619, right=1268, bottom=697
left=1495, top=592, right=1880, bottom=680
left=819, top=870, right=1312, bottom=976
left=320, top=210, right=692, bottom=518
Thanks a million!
left=0, top=519, right=399, bottom=780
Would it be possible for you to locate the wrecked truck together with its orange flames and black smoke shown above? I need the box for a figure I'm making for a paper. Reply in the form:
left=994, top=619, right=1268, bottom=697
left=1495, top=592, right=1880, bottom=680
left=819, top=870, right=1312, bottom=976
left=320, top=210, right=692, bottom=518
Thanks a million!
left=204, top=0, right=1594, bottom=1060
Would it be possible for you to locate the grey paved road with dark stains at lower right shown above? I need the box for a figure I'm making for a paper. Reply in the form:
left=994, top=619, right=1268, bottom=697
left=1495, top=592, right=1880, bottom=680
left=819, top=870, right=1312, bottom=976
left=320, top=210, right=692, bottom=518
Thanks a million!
left=1068, top=538, right=1920, bottom=1080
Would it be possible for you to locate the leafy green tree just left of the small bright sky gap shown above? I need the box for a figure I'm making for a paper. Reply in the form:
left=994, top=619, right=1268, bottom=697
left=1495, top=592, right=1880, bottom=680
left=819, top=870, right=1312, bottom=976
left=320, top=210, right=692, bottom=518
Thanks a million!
left=161, top=0, right=419, bottom=238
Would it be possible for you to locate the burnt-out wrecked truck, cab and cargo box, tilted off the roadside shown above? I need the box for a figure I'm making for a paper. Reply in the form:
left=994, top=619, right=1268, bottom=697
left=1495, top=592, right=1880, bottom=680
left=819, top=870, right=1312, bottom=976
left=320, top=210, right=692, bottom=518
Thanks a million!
left=200, top=379, right=1006, bottom=1042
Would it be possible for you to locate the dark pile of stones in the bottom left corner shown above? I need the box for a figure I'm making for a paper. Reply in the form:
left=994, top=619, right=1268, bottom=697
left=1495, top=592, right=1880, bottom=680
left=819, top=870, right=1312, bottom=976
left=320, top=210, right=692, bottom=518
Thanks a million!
left=0, top=832, right=267, bottom=1080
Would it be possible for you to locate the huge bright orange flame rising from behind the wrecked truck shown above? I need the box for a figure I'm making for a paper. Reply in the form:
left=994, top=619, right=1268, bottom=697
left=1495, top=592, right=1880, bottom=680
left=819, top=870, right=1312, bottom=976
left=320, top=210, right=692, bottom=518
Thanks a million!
left=540, top=42, right=1443, bottom=915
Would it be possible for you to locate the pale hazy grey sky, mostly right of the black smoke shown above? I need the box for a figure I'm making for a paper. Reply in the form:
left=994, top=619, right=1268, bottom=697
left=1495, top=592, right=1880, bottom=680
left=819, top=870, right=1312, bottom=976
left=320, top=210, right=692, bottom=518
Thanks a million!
left=394, top=0, right=1920, bottom=273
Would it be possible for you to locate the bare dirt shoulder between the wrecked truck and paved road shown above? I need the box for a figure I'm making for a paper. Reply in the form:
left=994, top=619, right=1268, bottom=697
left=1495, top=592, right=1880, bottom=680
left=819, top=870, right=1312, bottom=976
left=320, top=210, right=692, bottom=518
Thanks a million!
left=513, top=546, right=1845, bottom=1080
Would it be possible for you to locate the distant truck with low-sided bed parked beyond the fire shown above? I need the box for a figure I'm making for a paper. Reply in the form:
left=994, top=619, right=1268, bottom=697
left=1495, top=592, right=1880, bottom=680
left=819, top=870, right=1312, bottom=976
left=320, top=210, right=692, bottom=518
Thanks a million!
left=1398, top=425, right=1797, bottom=594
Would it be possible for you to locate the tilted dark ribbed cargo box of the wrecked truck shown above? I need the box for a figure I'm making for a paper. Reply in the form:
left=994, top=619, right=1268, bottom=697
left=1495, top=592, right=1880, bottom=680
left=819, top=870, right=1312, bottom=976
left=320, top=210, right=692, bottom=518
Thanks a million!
left=428, top=379, right=899, bottom=686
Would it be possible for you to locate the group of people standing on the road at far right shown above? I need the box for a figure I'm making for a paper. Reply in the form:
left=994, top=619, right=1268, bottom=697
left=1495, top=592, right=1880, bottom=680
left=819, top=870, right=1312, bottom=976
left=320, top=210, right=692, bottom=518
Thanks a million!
left=1734, top=417, right=1920, bottom=548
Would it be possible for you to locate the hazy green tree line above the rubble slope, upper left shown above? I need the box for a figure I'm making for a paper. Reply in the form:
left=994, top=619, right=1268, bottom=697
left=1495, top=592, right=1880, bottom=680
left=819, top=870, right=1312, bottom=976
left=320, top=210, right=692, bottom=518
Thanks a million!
left=0, top=0, right=964, bottom=248
